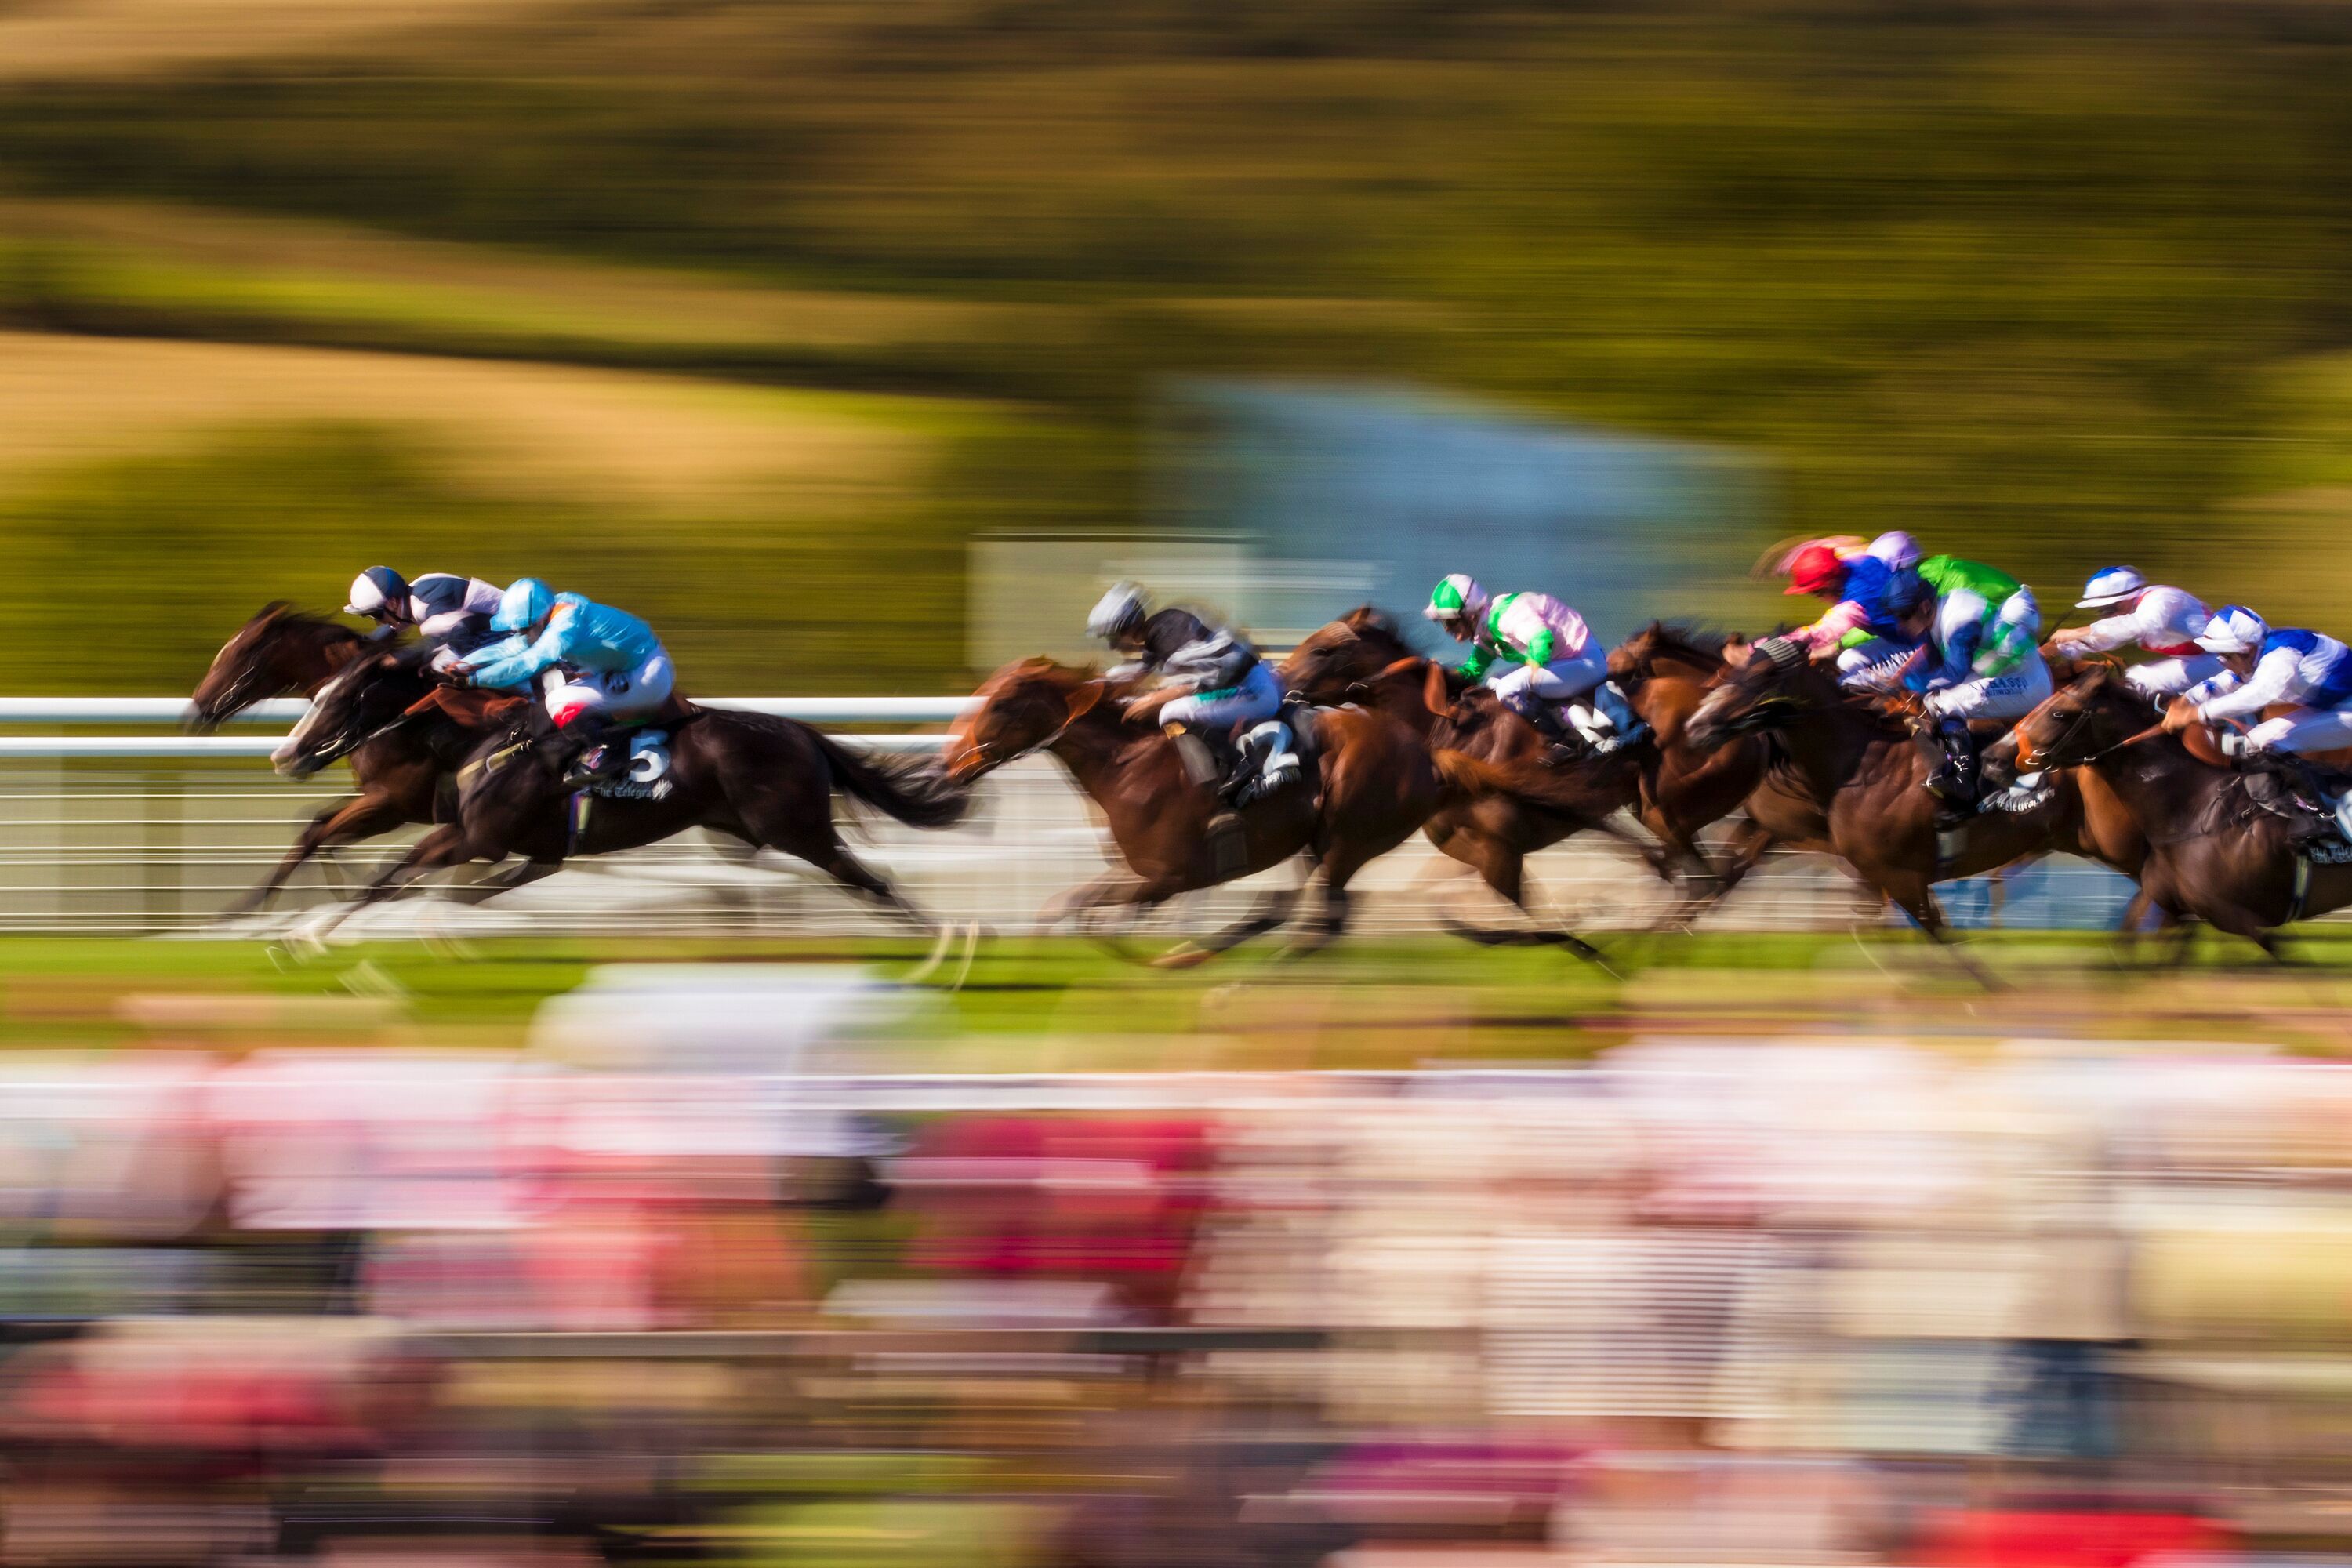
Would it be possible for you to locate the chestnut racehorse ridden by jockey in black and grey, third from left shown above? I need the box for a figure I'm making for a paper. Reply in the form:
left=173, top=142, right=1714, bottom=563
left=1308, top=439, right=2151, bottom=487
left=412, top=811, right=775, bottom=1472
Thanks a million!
left=943, top=659, right=1442, bottom=964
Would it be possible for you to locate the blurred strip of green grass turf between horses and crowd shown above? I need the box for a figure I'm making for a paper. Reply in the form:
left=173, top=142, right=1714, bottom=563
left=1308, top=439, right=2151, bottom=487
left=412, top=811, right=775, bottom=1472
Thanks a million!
left=0, top=931, right=2352, bottom=1072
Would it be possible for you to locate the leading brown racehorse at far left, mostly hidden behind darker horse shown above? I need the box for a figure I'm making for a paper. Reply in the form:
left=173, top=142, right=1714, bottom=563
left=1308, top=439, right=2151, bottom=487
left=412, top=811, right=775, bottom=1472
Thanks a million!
left=188, top=600, right=452, bottom=914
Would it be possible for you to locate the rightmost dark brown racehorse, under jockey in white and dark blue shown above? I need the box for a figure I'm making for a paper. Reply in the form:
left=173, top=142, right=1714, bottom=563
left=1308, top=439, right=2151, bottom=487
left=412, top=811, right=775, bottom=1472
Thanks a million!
left=1985, top=666, right=2352, bottom=959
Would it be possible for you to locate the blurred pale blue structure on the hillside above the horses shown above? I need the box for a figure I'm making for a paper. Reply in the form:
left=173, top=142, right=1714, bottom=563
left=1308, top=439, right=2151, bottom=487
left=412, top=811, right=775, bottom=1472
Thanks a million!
left=1160, top=381, right=1757, bottom=652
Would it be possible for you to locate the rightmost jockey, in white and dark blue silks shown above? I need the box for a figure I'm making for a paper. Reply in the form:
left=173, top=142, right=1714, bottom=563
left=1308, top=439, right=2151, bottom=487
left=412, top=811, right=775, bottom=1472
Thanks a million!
left=2164, top=604, right=2352, bottom=757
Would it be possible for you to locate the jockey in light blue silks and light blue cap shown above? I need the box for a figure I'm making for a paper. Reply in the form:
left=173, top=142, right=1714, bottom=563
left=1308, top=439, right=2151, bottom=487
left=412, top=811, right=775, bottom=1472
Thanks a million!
left=449, top=579, right=675, bottom=789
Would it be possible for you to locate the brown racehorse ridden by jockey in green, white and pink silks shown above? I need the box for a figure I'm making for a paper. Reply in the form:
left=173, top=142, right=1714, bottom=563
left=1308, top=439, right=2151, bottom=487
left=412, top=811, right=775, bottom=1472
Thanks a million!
left=1277, top=604, right=1675, bottom=947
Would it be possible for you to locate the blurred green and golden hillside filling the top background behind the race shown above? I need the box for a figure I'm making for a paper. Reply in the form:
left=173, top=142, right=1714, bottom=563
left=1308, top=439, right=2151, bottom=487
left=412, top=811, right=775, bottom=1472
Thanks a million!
left=0, top=0, right=2352, bottom=691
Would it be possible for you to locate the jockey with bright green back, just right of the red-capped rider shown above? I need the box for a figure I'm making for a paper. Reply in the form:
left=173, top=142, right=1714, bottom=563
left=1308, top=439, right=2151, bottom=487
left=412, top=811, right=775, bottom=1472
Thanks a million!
left=1903, top=555, right=2051, bottom=815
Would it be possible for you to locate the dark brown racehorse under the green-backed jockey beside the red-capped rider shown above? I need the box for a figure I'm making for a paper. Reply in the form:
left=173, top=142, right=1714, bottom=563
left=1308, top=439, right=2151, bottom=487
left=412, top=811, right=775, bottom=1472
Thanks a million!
left=1684, top=640, right=2145, bottom=978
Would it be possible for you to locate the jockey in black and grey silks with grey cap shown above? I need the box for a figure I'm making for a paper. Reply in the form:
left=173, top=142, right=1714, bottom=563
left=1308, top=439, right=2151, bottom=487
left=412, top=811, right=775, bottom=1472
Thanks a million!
left=1087, top=583, right=1301, bottom=806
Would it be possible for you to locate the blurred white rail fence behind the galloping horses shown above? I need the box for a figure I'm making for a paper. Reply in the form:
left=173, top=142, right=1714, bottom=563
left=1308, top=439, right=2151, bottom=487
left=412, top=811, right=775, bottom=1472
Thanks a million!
left=0, top=696, right=2154, bottom=935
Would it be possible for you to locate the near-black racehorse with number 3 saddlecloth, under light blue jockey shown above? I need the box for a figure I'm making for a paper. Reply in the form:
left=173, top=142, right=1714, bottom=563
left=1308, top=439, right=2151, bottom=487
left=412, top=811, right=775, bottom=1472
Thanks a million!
left=275, top=654, right=969, bottom=931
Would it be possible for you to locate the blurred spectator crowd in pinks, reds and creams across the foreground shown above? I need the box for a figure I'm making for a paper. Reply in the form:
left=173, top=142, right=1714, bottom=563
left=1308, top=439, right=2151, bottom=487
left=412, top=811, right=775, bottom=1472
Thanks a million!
left=0, top=992, right=2352, bottom=1568
